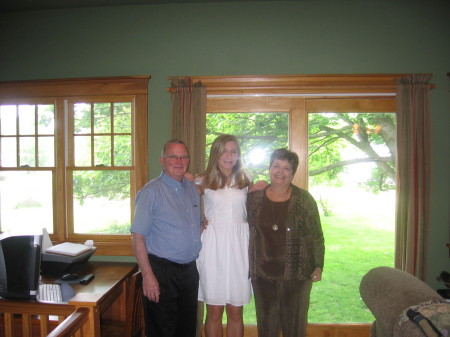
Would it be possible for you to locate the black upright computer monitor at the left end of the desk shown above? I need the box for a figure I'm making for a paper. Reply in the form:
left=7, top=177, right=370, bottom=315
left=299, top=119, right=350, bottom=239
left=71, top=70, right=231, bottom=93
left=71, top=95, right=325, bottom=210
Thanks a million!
left=0, top=233, right=42, bottom=299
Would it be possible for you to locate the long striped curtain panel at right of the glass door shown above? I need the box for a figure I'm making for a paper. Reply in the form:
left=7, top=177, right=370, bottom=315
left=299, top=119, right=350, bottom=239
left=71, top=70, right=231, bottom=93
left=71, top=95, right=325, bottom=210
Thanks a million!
left=395, top=74, right=431, bottom=281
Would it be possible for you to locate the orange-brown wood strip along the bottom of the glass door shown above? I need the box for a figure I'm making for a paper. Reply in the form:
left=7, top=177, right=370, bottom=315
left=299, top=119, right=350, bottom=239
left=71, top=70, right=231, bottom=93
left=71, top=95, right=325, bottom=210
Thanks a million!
left=202, top=324, right=370, bottom=337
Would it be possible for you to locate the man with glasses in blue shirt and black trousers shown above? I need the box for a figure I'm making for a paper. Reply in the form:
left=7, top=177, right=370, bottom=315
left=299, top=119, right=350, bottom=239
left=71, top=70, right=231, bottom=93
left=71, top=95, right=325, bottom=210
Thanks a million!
left=131, top=139, right=201, bottom=337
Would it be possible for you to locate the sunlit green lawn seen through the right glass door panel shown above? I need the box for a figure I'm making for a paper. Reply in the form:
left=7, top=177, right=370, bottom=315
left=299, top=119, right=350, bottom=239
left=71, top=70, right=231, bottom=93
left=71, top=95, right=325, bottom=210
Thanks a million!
left=309, top=217, right=394, bottom=323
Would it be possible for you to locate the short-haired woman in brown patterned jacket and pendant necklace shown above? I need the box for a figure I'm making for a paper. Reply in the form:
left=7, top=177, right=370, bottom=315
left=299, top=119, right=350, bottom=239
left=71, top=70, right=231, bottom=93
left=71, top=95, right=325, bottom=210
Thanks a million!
left=247, top=149, right=325, bottom=337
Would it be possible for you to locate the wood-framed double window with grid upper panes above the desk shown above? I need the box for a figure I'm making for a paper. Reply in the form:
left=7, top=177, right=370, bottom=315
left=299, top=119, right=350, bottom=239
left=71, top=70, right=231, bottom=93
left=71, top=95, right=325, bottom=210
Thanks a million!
left=0, top=77, right=149, bottom=255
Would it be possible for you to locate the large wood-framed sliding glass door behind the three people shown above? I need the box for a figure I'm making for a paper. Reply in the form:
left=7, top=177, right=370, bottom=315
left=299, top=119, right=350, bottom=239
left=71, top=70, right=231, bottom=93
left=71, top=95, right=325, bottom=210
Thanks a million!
left=199, top=78, right=397, bottom=324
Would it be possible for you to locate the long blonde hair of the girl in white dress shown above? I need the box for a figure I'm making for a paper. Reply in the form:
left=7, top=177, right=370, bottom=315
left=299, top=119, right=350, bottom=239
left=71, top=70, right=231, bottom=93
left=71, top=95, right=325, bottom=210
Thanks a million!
left=199, top=134, right=251, bottom=190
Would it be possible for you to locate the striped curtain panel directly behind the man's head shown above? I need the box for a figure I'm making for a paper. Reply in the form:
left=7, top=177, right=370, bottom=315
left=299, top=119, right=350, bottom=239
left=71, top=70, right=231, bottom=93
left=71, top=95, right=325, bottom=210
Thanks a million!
left=170, top=77, right=206, bottom=174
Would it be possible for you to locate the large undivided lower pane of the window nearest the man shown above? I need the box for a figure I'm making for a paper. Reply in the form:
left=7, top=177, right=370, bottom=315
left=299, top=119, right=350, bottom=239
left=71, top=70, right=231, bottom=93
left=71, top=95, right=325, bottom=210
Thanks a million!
left=73, top=170, right=131, bottom=234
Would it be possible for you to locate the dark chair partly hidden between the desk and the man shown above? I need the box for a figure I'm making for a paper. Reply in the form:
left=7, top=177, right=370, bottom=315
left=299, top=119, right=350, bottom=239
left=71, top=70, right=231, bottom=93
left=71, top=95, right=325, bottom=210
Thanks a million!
left=101, top=271, right=145, bottom=337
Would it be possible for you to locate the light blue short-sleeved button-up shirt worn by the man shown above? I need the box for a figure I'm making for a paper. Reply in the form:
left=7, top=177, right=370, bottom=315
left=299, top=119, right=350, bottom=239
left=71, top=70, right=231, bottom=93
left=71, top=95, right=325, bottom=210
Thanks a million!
left=131, top=171, right=201, bottom=263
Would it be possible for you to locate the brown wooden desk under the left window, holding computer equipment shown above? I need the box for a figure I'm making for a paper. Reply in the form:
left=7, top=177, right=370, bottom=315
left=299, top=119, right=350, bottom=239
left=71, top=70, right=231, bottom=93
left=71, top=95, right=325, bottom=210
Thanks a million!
left=0, top=261, right=138, bottom=337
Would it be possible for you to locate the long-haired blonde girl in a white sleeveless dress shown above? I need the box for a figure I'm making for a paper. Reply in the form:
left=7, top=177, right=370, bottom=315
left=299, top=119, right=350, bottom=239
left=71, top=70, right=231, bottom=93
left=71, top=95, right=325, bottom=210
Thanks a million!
left=196, top=135, right=267, bottom=337
